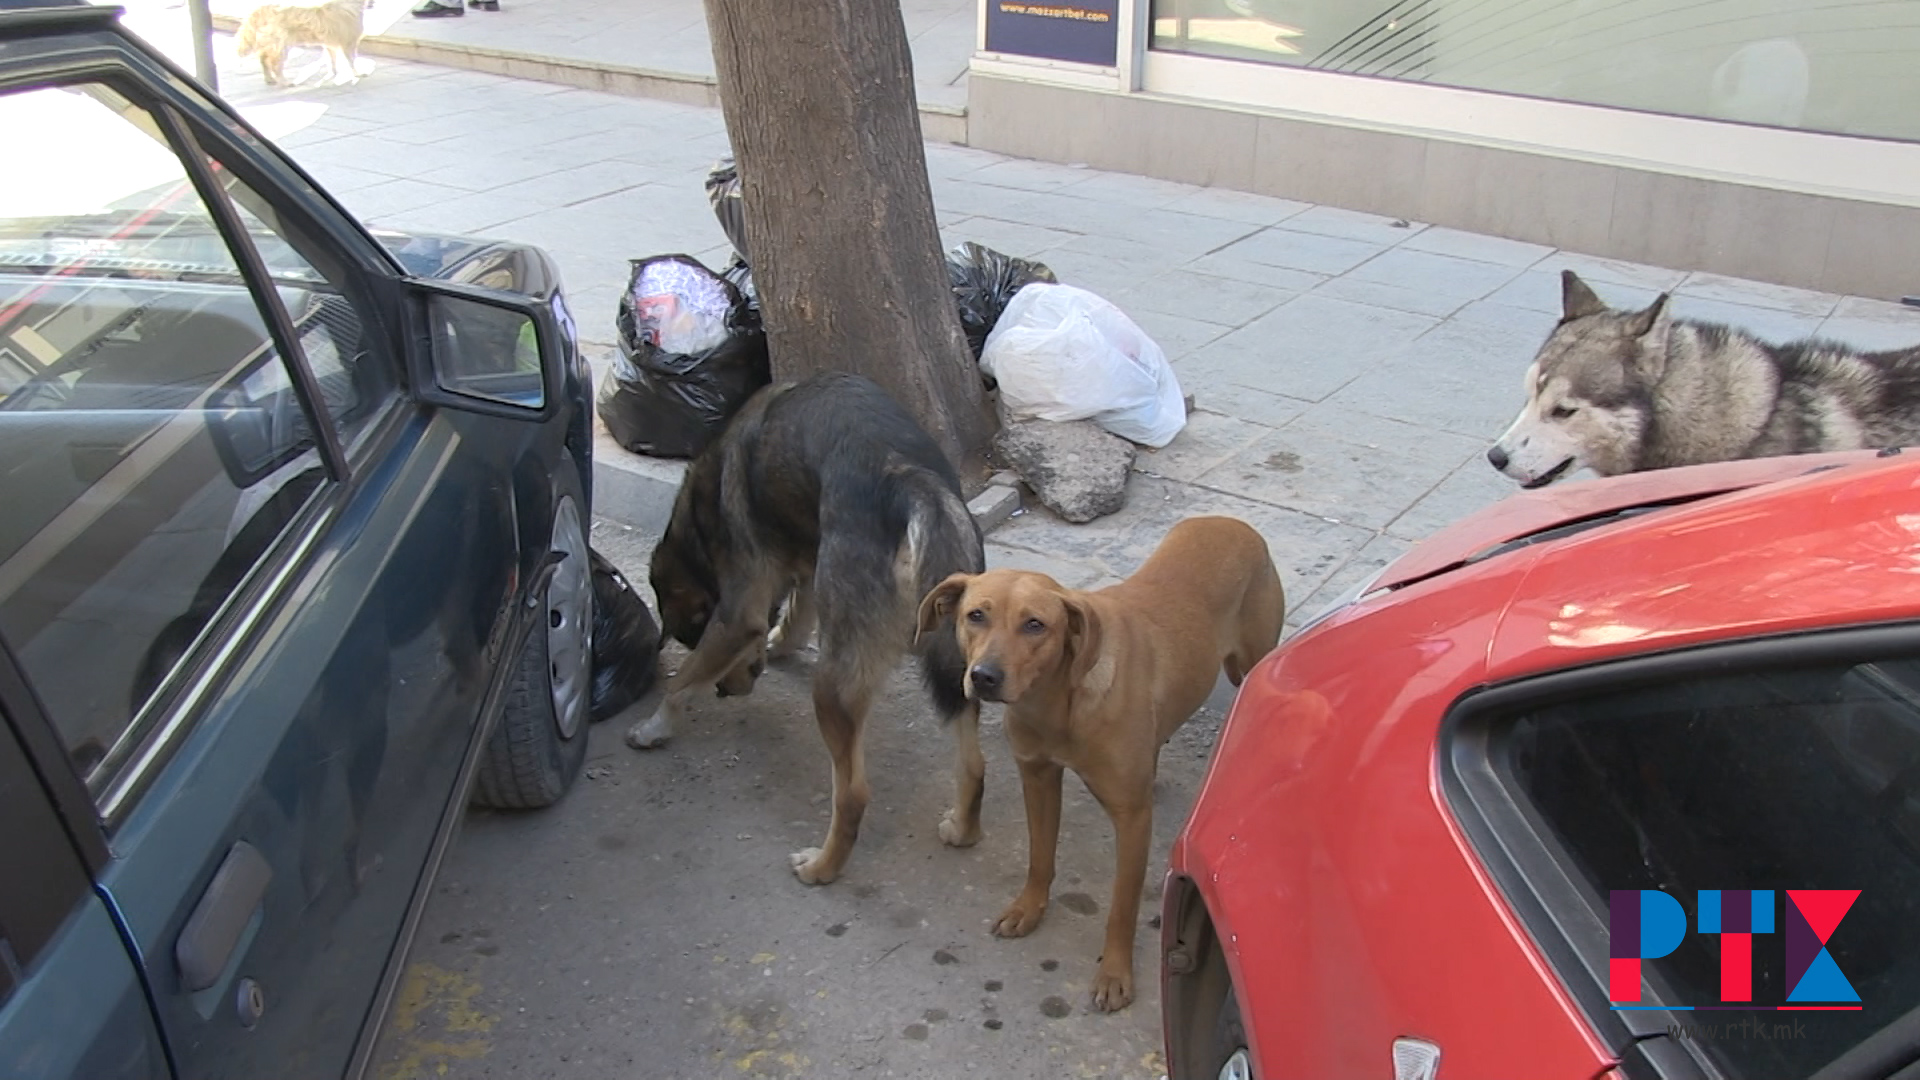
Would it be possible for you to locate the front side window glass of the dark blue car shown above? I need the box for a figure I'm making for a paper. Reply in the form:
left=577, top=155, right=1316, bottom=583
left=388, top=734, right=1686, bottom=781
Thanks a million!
left=0, top=85, right=385, bottom=794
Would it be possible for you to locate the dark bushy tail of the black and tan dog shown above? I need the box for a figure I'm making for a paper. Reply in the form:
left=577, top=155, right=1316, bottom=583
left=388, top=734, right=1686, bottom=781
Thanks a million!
left=889, top=471, right=987, bottom=721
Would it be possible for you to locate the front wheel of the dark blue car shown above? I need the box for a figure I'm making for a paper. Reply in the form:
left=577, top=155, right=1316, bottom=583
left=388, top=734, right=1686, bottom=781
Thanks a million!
left=472, top=490, right=593, bottom=809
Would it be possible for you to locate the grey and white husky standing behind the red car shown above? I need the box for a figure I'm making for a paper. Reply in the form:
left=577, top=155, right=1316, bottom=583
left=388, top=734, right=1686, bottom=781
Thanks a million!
left=1486, top=271, right=1920, bottom=488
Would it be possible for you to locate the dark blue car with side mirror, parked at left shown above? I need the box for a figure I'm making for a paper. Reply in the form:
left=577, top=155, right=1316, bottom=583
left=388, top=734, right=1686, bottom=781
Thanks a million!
left=0, top=0, right=593, bottom=1080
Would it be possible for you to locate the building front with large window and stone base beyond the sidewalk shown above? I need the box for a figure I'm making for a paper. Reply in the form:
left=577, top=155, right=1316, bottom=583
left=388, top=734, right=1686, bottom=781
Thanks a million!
left=968, top=0, right=1920, bottom=298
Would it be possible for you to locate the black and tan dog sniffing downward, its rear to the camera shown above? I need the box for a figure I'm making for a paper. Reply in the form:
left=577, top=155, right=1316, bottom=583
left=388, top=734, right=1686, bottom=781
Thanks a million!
left=626, top=375, right=987, bottom=884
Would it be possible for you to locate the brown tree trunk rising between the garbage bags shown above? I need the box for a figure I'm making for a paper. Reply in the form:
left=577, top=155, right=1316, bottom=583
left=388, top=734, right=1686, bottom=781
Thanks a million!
left=707, top=0, right=993, bottom=480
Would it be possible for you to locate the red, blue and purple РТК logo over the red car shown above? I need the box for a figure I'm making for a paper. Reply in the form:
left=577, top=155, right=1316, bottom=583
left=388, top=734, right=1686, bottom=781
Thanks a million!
left=1607, top=890, right=1860, bottom=1009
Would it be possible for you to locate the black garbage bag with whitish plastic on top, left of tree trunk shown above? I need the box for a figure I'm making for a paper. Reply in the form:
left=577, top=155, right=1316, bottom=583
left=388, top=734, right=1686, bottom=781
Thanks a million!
left=597, top=256, right=772, bottom=457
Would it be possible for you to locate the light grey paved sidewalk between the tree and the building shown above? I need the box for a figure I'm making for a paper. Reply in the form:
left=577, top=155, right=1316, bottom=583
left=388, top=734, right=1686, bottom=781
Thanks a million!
left=183, top=42, right=1920, bottom=615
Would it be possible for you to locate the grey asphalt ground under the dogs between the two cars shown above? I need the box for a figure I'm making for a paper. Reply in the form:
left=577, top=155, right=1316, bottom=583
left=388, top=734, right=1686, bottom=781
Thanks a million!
left=376, top=521, right=1225, bottom=1080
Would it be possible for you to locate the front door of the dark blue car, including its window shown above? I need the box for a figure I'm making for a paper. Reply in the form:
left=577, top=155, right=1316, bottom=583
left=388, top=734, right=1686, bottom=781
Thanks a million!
left=0, top=61, right=522, bottom=1080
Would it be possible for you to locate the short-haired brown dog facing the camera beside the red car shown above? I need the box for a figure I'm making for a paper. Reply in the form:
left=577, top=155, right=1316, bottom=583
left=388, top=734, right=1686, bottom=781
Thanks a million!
left=920, top=517, right=1286, bottom=1011
